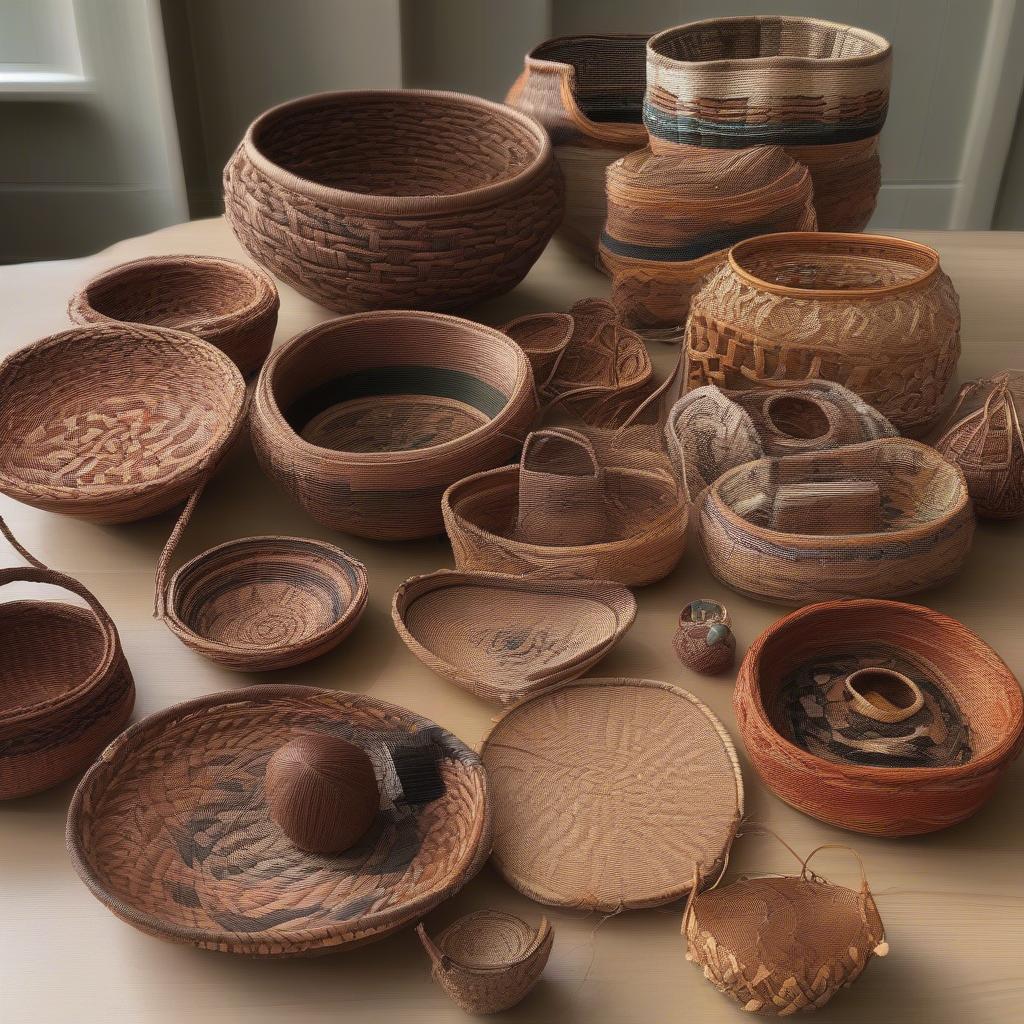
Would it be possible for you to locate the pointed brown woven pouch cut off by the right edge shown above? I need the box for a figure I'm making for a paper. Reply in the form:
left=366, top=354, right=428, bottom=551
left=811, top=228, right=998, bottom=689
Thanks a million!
left=935, top=370, right=1024, bottom=519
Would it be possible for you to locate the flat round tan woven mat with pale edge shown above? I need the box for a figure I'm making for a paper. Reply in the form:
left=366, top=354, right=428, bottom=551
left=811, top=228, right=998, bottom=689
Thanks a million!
left=480, top=679, right=743, bottom=912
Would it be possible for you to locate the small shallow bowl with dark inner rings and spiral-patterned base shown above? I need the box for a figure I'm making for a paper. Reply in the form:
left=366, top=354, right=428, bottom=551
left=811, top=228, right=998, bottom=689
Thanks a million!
left=164, top=537, right=369, bottom=672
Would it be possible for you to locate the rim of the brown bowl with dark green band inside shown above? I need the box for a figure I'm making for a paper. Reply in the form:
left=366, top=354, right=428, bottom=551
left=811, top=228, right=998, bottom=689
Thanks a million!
left=254, top=309, right=536, bottom=469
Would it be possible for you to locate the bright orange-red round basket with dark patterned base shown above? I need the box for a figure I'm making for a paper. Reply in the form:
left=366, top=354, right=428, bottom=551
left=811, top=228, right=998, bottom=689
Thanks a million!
left=733, top=600, right=1024, bottom=836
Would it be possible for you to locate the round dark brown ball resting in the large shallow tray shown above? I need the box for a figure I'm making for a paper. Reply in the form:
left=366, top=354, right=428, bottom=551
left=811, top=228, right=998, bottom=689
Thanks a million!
left=264, top=733, right=380, bottom=853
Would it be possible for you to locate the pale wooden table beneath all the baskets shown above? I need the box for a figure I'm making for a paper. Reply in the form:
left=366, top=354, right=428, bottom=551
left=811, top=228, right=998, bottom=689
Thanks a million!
left=0, top=220, right=1024, bottom=1024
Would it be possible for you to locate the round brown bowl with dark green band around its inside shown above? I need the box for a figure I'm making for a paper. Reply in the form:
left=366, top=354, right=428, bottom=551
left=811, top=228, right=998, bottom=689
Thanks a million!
left=251, top=311, right=537, bottom=540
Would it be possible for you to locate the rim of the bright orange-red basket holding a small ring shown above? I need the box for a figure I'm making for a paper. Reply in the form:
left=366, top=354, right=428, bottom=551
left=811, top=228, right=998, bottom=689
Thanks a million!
left=732, top=597, right=1024, bottom=786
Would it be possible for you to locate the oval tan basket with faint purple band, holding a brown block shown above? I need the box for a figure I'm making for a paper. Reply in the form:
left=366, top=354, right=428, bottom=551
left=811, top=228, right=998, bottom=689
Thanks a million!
left=697, top=437, right=974, bottom=604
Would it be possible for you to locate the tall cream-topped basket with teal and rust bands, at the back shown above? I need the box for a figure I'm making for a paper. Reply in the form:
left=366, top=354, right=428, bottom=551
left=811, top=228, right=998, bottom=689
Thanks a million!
left=644, top=15, right=892, bottom=231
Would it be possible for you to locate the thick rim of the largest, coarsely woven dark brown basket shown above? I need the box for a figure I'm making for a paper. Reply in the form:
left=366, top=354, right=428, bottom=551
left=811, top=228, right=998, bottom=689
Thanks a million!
left=241, top=89, right=553, bottom=216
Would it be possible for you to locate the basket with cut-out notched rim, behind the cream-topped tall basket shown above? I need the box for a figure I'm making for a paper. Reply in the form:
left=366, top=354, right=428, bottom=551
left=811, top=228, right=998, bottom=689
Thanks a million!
left=505, top=35, right=647, bottom=253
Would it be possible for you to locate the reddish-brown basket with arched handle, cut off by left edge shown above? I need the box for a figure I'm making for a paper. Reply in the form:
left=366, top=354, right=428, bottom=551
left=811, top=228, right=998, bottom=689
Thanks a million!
left=0, top=519, right=135, bottom=800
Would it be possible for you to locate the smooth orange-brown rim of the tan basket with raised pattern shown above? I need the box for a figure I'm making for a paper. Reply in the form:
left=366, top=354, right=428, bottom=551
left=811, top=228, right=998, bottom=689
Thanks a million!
left=728, top=231, right=941, bottom=299
